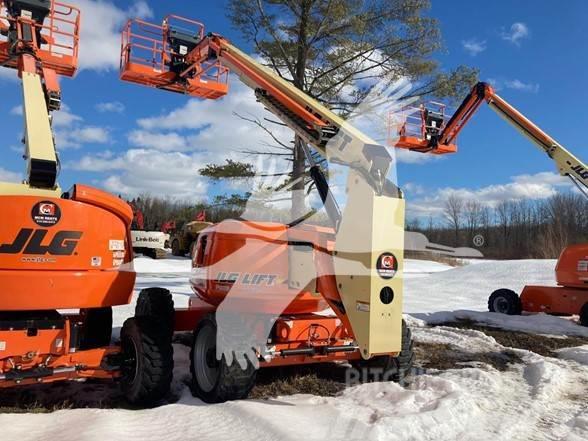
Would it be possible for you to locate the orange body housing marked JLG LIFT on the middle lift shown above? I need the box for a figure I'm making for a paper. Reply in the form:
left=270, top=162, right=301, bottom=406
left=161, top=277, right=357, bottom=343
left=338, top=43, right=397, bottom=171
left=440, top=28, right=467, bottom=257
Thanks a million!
left=190, top=220, right=340, bottom=314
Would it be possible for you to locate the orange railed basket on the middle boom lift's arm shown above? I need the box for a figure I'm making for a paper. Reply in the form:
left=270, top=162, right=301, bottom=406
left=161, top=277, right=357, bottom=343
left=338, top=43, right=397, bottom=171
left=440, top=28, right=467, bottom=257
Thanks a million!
left=120, top=15, right=229, bottom=99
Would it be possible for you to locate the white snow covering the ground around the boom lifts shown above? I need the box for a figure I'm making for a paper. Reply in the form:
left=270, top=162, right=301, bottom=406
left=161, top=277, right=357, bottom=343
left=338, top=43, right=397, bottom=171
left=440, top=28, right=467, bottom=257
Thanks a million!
left=0, top=258, right=588, bottom=441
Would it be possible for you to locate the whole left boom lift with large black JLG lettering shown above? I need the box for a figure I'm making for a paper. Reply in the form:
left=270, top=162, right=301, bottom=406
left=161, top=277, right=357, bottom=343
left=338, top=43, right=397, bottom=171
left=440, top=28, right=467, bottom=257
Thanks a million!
left=0, top=0, right=173, bottom=403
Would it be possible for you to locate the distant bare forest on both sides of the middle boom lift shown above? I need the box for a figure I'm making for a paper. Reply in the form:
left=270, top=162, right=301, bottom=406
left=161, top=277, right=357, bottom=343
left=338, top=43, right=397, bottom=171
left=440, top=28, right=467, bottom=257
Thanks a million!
left=133, top=193, right=588, bottom=259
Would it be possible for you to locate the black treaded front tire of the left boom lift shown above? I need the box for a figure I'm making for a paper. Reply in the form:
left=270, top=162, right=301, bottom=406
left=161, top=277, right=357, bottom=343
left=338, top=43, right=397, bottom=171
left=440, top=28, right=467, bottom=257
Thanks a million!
left=120, top=317, right=174, bottom=407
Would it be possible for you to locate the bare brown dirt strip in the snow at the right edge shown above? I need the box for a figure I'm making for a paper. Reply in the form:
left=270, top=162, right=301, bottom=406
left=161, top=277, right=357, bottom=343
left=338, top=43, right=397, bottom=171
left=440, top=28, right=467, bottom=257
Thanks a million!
left=436, top=320, right=588, bottom=357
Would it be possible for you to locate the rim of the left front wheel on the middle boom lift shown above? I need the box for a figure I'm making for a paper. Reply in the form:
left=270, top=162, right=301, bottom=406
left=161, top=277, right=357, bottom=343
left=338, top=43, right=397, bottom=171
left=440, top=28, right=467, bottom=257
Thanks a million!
left=192, top=325, right=219, bottom=392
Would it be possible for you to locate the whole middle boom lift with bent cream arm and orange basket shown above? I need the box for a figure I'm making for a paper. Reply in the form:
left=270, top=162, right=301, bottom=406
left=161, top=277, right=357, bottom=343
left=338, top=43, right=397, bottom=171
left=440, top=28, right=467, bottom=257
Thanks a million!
left=121, top=16, right=422, bottom=402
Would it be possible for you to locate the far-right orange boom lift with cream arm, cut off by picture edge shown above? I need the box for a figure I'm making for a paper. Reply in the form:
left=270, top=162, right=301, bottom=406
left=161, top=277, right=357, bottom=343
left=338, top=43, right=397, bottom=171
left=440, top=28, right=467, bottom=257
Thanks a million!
left=398, top=83, right=588, bottom=326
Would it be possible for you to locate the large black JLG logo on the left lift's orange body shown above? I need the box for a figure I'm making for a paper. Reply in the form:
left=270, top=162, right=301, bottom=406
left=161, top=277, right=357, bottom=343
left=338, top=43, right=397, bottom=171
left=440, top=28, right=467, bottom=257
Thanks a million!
left=0, top=228, right=82, bottom=256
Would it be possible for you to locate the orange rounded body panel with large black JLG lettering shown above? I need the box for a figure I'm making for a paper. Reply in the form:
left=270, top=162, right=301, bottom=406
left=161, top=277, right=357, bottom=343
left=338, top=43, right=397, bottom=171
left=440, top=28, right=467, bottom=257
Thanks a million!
left=0, top=186, right=135, bottom=311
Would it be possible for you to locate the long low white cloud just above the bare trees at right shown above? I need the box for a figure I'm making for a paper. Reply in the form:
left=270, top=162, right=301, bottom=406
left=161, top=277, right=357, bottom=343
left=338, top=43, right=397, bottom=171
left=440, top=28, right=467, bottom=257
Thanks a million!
left=407, top=172, right=573, bottom=216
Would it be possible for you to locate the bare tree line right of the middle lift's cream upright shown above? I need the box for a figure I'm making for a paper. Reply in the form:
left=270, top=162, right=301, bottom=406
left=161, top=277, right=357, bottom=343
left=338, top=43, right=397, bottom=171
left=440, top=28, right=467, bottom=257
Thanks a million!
left=407, top=193, right=588, bottom=259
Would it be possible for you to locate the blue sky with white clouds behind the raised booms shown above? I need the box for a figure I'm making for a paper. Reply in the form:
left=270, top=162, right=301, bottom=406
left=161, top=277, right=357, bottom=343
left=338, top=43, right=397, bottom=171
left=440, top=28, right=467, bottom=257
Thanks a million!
left=0, top=0, right=588, bottom=216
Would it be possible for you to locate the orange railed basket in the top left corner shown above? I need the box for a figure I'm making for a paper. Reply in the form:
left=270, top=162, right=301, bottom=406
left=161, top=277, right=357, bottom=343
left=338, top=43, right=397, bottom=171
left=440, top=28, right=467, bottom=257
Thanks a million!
left=0, top=0, right=80, bottom=77
